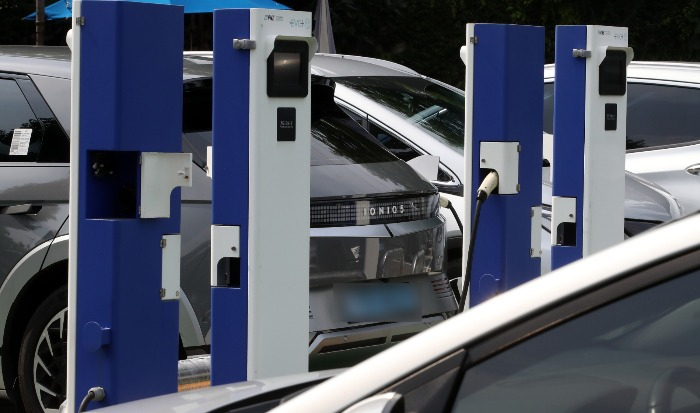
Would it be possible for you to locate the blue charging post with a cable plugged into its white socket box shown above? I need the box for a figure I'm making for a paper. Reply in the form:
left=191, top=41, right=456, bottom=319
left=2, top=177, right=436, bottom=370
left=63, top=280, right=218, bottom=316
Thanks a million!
left=461, top=24, right=544, bottom=306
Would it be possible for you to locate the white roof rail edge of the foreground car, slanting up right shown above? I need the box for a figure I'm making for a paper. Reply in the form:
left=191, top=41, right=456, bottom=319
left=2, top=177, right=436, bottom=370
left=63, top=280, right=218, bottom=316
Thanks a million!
left=272, top=214, right=700, bottom=412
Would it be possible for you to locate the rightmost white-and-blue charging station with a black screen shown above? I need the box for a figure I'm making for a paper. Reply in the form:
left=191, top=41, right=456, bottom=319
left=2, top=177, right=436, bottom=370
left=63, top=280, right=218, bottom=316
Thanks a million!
left=551, top=26, right=633, bottom=269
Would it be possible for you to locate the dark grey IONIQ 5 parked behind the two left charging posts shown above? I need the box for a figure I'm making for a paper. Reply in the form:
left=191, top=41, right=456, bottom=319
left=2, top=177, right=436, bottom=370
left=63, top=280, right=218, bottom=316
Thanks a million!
left=0, top=46, right=456, bottom=412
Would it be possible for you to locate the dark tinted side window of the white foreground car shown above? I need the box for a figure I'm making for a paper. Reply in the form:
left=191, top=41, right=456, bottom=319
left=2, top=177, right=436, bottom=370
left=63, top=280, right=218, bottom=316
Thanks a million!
left=453, top=270, right=700, bottom=413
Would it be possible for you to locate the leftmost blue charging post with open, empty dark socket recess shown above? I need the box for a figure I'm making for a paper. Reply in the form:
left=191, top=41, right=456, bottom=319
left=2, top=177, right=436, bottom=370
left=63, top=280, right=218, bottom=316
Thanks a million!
left=67, top=0, right=191, bottom=412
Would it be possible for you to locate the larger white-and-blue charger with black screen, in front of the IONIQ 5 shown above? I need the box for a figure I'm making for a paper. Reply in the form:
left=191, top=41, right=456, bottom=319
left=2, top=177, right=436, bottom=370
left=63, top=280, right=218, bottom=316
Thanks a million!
left=210, top=9, right=316, bottom=384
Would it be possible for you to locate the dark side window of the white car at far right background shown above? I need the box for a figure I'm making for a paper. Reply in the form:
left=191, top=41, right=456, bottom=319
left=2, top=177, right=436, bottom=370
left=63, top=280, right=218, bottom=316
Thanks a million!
left=627, top=83, right=700, bottom=149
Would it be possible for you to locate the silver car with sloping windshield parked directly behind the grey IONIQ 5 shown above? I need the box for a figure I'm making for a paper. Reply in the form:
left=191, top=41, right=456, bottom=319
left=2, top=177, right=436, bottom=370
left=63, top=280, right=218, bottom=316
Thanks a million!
left=312, top=54, right=682, bottom=279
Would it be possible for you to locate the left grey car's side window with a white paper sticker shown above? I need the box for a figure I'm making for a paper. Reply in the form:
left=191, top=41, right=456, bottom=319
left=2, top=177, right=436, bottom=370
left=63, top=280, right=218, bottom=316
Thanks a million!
left=0, top=79, right=43, bottom=162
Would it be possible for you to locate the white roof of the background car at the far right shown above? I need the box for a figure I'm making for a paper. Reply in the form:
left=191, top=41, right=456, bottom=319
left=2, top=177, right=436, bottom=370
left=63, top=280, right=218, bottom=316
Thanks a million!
left=544, top=60, right=700, bottom=84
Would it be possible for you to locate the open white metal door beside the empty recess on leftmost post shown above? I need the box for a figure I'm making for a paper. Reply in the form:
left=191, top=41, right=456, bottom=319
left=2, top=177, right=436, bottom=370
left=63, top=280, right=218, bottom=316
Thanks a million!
left=139, top=152, right=192, bottom=218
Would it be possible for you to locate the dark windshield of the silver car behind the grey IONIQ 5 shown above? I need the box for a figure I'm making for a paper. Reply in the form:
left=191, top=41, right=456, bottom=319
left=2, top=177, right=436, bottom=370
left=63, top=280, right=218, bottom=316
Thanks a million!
left=334, top=76, right=464, bottom=154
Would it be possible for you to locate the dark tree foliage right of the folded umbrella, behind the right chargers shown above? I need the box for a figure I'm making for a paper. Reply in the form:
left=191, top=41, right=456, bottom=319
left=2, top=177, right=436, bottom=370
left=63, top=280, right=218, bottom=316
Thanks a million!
left=330, top=0, right=700, bottom=86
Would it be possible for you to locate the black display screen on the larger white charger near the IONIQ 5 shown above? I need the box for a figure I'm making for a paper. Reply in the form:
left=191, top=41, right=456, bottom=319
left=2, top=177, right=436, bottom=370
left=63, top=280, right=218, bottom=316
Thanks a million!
left=267, top=40, right=309, bottom=98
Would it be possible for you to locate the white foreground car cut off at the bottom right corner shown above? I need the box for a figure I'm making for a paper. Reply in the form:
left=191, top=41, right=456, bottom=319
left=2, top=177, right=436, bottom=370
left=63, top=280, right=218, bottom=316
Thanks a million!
left=85, top=202, right=700, bottom=413
